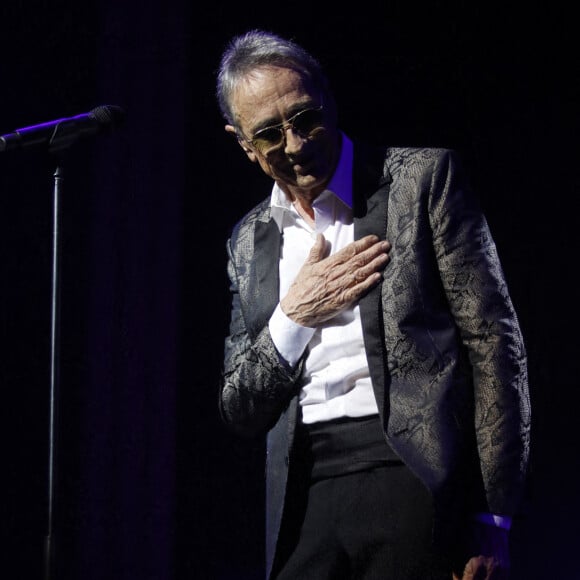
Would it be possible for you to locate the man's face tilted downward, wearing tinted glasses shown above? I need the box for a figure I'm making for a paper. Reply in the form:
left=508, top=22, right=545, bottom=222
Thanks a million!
left=226, top=67, right=340, bottom=200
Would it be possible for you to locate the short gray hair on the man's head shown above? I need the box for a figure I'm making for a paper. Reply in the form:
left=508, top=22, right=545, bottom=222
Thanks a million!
left=216, top=30, right=328, bottom=125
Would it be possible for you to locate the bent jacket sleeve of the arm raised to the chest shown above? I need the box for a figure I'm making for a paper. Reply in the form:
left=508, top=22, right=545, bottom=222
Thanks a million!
left=219, top=233, right=303, bottom=437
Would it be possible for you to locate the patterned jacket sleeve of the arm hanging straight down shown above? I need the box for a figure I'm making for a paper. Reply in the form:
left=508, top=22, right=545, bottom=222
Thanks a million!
left=429, top=152, right=530, bottom=514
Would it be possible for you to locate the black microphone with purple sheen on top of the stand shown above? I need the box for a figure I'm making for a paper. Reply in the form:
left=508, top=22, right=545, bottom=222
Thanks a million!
left=0, top=105, right=125, bottom=152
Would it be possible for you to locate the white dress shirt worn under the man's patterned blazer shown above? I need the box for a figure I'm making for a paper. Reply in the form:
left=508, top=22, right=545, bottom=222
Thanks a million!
left=269, top=135, right=378, bottom=423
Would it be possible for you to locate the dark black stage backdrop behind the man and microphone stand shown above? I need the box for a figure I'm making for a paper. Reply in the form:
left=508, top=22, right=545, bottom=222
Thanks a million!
left=0, top=0, right=580, bottom=580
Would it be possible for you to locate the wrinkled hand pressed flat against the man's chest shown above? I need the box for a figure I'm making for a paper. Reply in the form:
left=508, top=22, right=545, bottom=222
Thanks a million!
left=280, top=234, right=391, bottom=327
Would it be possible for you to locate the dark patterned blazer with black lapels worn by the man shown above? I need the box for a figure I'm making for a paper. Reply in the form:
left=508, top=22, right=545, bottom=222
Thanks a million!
left=220, top=143, right=530, bottom=569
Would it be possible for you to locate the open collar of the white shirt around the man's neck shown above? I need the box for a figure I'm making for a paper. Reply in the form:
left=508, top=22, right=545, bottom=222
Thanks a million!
left=270, top=133, right=353, bottom=230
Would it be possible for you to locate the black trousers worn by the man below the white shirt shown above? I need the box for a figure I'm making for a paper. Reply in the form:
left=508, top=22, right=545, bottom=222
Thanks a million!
left=272, top=418, right=451, bottom=580
